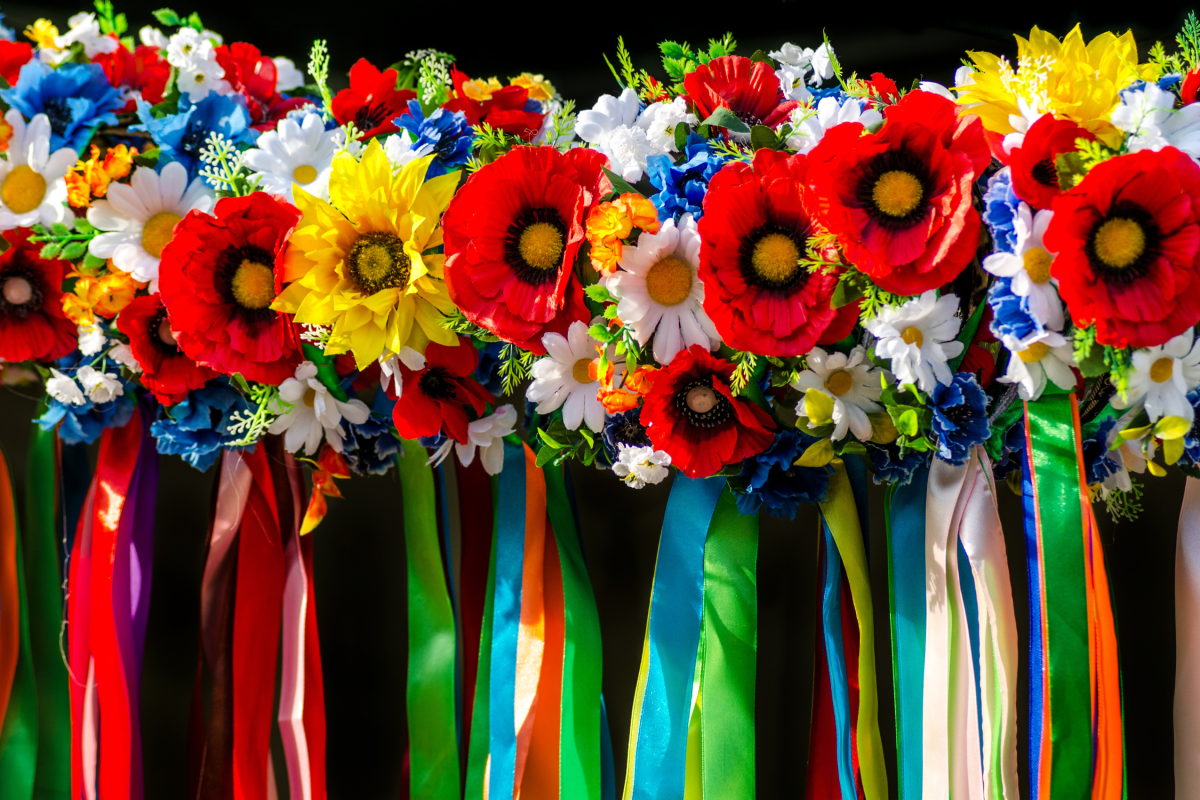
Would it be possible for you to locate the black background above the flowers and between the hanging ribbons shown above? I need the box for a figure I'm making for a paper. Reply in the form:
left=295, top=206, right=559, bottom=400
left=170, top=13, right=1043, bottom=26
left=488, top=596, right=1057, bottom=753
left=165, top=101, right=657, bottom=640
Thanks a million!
left=0, top=0, right=1184, bottom=800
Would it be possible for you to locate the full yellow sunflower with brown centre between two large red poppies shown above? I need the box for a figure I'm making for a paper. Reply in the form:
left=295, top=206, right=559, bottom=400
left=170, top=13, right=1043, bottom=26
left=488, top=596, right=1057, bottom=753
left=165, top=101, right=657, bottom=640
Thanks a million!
left=271, top=140, right=458, bottom=369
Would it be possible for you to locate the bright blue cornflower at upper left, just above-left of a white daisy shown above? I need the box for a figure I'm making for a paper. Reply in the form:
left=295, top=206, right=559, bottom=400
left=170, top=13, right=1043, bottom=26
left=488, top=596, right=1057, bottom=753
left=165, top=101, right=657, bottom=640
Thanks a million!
left=130, top=95, right=257, bottom=181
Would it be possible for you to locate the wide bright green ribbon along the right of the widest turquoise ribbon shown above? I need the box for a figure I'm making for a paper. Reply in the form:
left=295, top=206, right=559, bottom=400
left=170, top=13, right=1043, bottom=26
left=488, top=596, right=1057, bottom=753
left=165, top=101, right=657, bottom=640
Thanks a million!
left=689, top=489, right=758, bottom=798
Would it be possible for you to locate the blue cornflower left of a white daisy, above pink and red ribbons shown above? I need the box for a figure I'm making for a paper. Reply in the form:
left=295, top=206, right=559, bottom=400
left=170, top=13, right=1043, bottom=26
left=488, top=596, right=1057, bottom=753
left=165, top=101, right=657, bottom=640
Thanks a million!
left=150, top=379, right=252, bottom=471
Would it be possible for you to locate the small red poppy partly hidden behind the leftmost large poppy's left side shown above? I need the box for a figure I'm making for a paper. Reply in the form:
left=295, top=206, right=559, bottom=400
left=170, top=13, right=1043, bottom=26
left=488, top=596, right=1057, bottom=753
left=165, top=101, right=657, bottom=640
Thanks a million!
left=116, top=295, right=217, bottom=405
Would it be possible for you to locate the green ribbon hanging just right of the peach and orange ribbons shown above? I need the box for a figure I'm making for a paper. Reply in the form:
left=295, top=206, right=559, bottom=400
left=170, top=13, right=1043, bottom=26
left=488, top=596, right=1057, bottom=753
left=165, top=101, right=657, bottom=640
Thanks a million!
left=542, top=467, right=600, bottom=800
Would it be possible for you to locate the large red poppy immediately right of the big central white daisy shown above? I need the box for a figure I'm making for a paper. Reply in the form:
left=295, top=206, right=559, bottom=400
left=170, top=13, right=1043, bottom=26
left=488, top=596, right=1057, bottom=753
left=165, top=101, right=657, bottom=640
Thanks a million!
left=698, top=149, right=858, bottom=356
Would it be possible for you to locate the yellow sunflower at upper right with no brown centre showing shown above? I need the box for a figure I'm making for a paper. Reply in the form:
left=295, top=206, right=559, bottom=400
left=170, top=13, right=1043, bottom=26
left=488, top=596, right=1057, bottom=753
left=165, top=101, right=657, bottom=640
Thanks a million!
left=959, top=25, right=1158, bottom=146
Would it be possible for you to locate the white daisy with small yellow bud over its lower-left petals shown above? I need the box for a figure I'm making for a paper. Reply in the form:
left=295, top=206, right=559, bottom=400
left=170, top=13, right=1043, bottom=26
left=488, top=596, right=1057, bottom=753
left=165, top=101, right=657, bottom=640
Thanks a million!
left=792, top=344, right=883, bottom=441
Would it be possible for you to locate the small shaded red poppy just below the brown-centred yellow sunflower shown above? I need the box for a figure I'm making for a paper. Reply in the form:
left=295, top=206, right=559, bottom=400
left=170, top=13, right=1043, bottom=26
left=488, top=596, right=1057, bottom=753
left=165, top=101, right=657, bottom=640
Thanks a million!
left=391, top=337, right=494, bottom=444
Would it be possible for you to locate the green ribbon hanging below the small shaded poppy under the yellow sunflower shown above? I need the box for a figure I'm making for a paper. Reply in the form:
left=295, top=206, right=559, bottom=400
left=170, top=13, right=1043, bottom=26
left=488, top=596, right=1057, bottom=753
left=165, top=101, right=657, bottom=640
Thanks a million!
left=396, top=440, right=460, bottom=800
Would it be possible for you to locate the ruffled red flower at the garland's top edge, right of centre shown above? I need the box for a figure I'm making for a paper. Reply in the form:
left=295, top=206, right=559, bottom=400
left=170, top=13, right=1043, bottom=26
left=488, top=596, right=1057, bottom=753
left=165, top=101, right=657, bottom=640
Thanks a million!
left=683, top=55, right=800, bottom=128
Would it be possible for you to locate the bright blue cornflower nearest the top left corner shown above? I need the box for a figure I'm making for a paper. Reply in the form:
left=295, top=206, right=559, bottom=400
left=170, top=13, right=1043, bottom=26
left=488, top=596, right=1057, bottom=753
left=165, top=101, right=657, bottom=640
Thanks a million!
left=0, top=59, right=125, bottom=155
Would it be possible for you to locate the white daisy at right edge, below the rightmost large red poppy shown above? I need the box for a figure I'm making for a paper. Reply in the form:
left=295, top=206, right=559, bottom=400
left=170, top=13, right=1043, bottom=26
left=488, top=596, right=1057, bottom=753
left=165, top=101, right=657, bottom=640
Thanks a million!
left=1111, top=330, right=1200, bottom=422
